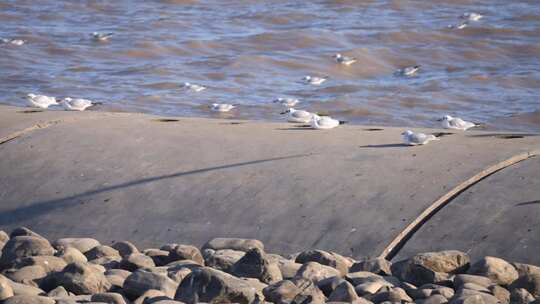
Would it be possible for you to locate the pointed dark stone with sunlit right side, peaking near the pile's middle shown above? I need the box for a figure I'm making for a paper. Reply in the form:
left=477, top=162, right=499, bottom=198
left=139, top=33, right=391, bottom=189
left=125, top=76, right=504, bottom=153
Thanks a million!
left=231, top=248, right=283, bottom=284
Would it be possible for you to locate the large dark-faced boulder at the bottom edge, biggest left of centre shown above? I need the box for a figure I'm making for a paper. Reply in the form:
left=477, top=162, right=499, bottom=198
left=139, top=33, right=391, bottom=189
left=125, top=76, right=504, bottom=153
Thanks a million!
left=175, top=267, right=263, bottom=304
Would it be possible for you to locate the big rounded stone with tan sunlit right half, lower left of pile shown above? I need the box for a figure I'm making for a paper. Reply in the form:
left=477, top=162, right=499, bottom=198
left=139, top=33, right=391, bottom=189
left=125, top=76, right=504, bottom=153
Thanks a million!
left=55, top=263, right=111, bottom=295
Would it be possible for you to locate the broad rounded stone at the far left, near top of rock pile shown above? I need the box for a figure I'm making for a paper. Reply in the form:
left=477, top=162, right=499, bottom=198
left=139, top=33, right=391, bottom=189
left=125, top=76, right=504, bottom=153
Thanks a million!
left=0, top=236, right=54, bottom=265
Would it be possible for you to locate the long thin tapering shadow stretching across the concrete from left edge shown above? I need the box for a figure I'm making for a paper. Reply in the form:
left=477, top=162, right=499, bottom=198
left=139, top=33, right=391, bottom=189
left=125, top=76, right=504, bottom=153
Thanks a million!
left=0, top=153, right=313, bottom=226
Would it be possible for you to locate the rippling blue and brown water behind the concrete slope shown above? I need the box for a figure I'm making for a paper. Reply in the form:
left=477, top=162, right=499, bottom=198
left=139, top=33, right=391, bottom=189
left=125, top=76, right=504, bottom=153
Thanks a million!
left=0, top=0, right=540, bottom=131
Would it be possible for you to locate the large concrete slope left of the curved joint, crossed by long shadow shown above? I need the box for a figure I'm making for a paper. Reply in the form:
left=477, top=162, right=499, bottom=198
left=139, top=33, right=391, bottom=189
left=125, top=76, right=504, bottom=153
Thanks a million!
left=0, top=107, right=540, bottom=256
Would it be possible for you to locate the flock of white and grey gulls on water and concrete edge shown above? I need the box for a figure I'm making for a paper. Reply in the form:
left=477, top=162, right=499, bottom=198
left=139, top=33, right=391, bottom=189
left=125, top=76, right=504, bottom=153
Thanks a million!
left=8, top=13, right=483, bottom=146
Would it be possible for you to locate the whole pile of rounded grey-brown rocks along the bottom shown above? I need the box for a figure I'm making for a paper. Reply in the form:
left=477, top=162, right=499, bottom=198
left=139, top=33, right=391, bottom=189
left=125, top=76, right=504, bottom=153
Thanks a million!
left=0, top=228, right=540, bottom=304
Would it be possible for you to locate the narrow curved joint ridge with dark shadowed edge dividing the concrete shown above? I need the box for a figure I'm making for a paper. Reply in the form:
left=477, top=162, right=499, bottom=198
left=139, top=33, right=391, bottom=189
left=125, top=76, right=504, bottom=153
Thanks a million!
left=379, top=149, right=540, bottom=260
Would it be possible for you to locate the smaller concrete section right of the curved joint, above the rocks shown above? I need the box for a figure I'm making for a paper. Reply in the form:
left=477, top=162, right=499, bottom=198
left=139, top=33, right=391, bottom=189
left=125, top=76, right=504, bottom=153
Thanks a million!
left=396, top=157, right=540, bottom=265
